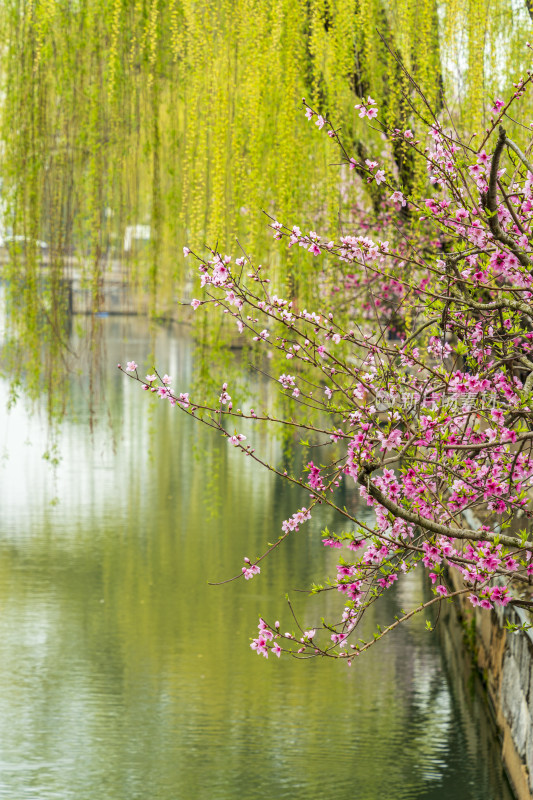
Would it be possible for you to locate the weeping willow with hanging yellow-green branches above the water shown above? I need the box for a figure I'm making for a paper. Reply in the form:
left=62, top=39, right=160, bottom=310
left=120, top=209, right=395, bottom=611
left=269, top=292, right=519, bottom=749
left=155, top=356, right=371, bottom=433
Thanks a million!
left=0, top=0, right=533, bottom=412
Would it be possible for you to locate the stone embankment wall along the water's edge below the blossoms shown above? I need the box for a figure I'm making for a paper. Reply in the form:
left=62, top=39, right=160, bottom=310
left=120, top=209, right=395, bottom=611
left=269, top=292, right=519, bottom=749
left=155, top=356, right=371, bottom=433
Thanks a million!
left=449, top=570, right=533, bottom=800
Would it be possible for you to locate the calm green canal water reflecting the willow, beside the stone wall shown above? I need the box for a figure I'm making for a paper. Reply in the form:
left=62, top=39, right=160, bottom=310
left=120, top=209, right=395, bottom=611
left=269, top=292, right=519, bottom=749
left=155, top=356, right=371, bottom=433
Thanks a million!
left=0, top=318, right=511, bottom=800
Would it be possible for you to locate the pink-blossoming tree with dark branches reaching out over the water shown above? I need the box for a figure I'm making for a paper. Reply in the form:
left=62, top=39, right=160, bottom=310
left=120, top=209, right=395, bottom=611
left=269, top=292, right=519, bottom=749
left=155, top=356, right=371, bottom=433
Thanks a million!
left=125, top=65, right=533, bottom=663
